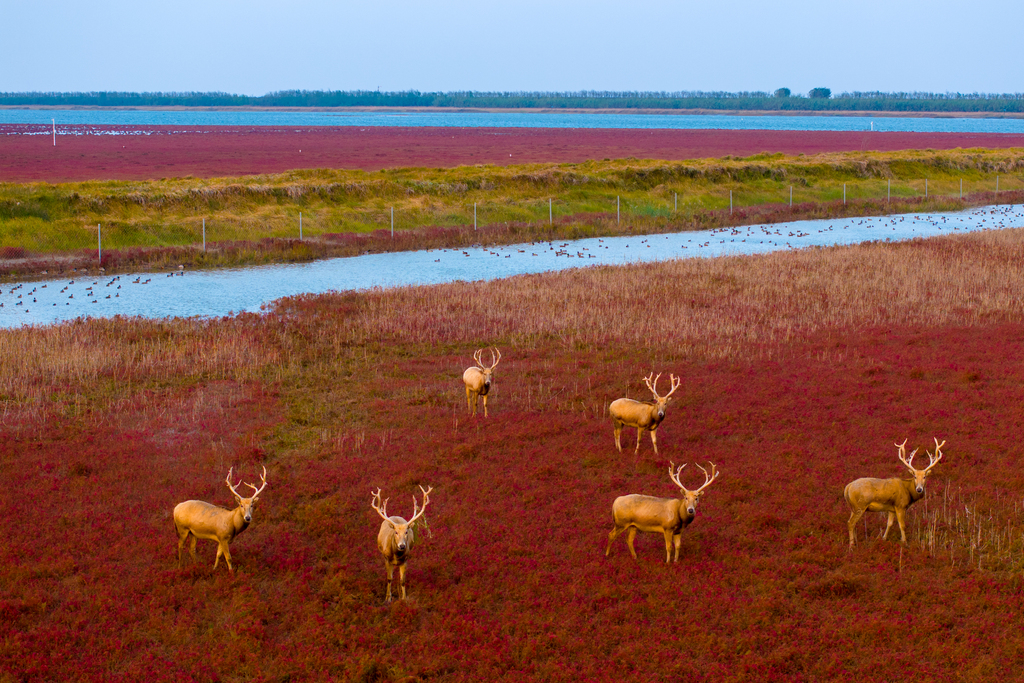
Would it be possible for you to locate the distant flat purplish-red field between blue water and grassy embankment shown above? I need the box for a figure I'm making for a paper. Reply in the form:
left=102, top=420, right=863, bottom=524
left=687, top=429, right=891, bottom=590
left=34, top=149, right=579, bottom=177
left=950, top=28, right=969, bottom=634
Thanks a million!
left=6, top=124, right=1024, bottom=182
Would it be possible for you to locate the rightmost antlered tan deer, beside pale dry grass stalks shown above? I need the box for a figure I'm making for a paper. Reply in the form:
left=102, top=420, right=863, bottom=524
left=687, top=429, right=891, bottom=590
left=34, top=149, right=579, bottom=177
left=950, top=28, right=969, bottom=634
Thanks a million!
left=843, top=437, right=946, bottom=550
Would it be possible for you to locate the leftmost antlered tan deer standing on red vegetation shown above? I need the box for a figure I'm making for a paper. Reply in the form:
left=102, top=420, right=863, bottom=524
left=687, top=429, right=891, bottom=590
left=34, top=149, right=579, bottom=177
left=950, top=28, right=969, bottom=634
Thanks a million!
left=174, top=466, right=266, bottom=573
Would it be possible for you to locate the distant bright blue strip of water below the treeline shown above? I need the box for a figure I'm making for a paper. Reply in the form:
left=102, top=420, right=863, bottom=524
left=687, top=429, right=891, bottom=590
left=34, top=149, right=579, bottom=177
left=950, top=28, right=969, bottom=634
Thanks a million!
left=6, top=109, right=1024, bottom=135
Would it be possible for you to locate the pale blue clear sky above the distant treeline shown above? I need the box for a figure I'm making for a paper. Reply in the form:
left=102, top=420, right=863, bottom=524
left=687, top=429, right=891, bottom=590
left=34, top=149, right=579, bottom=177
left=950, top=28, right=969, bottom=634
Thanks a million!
left=0, top=0, right=1024, bottom=95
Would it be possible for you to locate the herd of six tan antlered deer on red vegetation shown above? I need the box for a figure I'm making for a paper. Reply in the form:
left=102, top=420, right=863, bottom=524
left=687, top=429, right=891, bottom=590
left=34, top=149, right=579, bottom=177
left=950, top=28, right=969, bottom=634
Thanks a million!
left=174, top=348, right=946, bottom=602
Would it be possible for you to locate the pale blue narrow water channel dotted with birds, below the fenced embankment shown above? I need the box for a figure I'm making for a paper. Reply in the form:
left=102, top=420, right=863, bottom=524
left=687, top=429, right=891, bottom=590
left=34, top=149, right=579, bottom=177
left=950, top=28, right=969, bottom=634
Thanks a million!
left=0, top=205, right=1024, bottom=328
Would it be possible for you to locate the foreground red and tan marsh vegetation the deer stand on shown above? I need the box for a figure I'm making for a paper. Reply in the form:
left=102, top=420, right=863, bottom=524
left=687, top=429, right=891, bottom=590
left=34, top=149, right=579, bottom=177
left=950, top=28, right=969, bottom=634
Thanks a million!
left=0, top=230, right=1024, bottom=681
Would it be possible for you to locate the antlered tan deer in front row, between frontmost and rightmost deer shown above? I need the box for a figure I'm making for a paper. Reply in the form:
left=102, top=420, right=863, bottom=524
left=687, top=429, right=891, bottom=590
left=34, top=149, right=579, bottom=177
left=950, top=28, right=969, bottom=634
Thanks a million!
left=604, top=462, right=721, bottom=563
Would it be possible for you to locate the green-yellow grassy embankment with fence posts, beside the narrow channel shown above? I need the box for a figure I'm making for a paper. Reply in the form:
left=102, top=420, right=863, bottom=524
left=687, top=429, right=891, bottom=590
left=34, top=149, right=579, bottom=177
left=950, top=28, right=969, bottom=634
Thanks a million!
left=0, top=150, right=1024, bottom=276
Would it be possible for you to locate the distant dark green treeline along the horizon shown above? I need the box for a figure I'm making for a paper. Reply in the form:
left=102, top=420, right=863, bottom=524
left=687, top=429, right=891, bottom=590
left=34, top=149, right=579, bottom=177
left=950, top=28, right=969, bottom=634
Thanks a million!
left=0, top=88, right=1024, bottom=114
